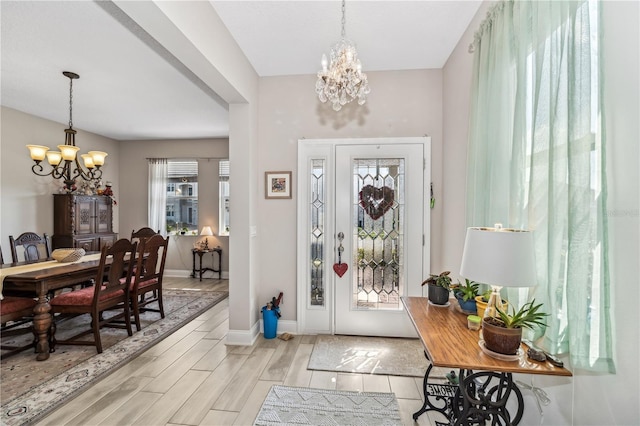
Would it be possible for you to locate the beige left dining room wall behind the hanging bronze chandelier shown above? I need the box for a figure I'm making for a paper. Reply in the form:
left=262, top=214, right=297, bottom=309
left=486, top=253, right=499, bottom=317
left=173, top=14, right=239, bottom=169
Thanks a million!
left=0, top=107, right=120, bottom=261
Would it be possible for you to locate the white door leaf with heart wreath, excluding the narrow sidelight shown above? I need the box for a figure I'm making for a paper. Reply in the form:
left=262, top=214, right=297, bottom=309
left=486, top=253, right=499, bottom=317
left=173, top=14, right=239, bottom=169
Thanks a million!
left=334, top=144, right=428, bottom=336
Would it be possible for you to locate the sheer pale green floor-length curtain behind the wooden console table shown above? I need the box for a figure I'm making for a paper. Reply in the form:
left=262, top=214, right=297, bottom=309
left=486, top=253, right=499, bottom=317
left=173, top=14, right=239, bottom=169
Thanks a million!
left=467, top=0, right=614, bottom=372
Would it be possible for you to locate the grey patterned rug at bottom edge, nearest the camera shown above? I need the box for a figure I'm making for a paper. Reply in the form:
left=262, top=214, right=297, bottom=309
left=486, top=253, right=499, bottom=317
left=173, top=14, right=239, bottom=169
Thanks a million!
left=254, top=385, right=402, bottom=426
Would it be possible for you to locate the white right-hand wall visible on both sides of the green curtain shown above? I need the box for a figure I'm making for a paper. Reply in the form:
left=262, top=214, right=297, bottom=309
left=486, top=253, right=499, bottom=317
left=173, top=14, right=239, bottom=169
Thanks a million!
left=442, top=1, right=640, bottom=425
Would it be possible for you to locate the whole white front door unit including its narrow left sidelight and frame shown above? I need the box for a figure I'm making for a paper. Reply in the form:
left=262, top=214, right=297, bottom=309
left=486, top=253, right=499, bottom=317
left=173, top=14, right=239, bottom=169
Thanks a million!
left=298, top=138, right=430, bottom=337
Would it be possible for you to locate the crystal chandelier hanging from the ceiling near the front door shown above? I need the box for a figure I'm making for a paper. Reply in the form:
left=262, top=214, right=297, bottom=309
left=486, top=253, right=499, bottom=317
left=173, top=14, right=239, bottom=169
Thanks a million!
left=316, top=0, right=371, bottom=111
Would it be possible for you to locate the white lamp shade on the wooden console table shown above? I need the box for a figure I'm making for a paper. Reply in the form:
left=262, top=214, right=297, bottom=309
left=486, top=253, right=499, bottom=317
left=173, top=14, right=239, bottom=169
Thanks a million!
left=460, top=228, right=537, bottom=287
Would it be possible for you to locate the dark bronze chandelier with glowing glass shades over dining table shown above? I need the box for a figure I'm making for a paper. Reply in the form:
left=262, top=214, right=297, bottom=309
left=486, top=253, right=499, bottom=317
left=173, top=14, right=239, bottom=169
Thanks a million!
left=27, top=71, right=108, bottom=191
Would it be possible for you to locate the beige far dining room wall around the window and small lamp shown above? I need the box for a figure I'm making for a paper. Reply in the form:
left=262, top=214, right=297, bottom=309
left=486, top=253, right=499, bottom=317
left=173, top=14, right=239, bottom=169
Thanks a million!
left=118, top=139, right=229, bottom=276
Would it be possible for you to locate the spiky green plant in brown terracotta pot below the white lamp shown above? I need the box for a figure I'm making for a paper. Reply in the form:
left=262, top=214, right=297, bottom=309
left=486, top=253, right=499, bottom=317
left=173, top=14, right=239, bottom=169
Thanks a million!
left=482, top=299, right=548, bottom=355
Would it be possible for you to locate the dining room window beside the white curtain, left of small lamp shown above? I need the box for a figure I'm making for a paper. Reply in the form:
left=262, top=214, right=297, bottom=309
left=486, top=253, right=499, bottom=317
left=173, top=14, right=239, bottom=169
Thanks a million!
left=166, top=160, right=198, bottom=234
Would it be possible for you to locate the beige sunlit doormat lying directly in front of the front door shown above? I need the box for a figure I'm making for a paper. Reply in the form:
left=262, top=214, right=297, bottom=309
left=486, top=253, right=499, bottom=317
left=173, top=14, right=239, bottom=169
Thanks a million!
left=307, top=334, right=447, bottom=377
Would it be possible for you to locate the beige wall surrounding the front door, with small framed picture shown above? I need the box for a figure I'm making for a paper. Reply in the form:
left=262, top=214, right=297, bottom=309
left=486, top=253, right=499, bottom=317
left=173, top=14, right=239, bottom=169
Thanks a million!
left=256, top=70, right=442, bottom=320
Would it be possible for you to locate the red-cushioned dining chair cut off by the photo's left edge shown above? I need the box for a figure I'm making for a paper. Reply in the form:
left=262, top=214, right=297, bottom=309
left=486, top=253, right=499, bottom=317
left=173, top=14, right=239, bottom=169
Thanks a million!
left=0, top=296, right=36, bottom=359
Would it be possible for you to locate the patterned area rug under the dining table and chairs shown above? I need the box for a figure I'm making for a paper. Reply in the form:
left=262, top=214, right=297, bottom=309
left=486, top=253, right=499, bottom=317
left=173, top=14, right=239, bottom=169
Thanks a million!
left=0, top=290, right=228, bottom=426
